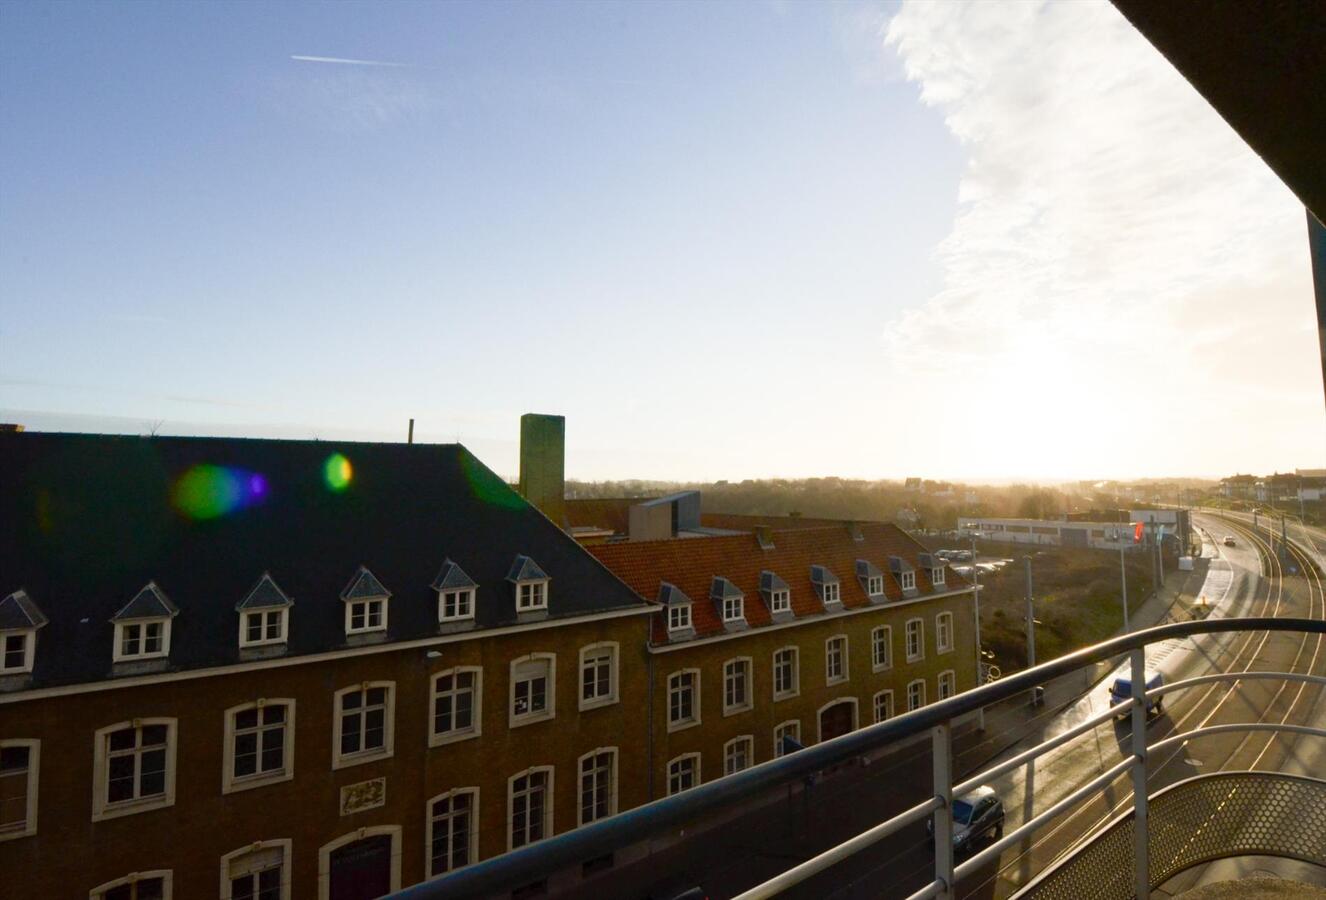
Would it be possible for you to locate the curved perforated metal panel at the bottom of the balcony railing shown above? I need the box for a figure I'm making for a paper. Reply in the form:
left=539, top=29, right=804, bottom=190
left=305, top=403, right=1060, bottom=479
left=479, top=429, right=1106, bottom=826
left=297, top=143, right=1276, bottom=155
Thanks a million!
left=1016, top=771, right=1326, bottom=900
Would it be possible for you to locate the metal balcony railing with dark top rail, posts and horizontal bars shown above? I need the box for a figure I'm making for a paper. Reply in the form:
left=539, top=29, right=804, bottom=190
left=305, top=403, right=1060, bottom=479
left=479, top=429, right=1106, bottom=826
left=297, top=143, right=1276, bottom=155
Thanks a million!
left=394, top=616, right=1326, bottom=900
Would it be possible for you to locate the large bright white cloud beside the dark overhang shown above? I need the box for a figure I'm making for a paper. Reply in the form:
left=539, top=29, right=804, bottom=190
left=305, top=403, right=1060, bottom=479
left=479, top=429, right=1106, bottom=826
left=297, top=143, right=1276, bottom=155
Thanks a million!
left=883, top=1, right=1326, bottom=475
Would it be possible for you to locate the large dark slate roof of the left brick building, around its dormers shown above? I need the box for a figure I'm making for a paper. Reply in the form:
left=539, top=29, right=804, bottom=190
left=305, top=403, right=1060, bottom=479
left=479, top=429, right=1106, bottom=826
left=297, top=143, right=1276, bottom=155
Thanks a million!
left=0, top=432, right=658, bottom=688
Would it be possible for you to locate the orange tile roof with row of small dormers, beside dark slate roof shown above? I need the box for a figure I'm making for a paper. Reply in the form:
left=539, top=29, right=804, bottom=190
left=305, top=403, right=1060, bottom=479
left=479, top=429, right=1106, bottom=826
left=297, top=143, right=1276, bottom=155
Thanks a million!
left=586, top=522, right=967, bottom=644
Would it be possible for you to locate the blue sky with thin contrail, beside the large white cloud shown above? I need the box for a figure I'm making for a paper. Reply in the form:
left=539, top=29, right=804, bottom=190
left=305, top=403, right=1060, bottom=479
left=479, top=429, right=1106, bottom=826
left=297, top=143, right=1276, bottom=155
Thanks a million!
left=0, top=3, right=1326, bottom=478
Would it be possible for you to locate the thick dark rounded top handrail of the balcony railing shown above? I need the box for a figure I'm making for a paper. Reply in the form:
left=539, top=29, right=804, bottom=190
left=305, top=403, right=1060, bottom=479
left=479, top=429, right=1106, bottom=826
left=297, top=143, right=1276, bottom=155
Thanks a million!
left=392, top=616, right=1326, bottom=900
